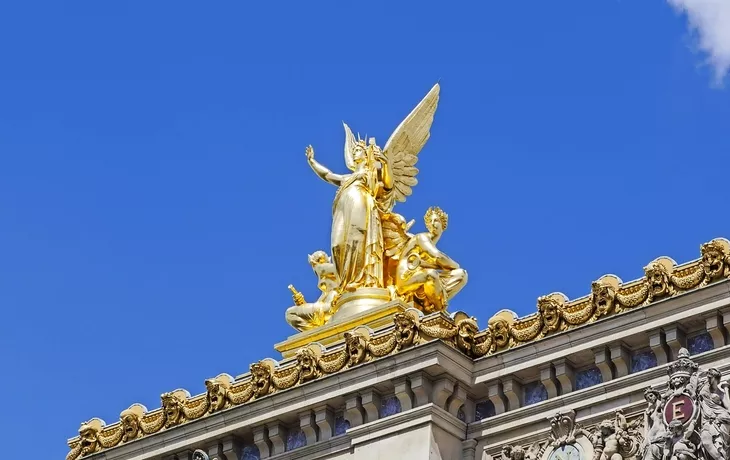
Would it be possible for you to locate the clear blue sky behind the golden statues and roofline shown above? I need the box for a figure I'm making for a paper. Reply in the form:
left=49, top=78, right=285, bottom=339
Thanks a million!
left=0, top=0, right=730, bottom=459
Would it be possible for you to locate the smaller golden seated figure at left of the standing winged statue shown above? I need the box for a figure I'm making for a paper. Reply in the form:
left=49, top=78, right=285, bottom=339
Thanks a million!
left=286, top=251, right=340, bottom=331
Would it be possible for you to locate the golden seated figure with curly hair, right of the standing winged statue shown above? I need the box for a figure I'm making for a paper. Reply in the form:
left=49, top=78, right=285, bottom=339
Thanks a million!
left=383, top=207, right=467, bottom=313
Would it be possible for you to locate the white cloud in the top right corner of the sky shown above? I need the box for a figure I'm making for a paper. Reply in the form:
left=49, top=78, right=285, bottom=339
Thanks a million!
left=667, top=0, right=730, bottom=84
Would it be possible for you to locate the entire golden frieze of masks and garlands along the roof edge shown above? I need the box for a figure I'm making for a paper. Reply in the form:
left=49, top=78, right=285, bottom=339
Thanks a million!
left=66, top=238, right=730, bottom=460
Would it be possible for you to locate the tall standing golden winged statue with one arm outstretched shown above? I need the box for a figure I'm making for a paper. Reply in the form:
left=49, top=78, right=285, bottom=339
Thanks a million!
left=287, top=84, right=466, bottom=330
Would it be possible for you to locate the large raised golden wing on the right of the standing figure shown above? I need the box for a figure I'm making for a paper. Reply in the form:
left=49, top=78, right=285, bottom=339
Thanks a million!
left=383, top=83, right=441, bottom=202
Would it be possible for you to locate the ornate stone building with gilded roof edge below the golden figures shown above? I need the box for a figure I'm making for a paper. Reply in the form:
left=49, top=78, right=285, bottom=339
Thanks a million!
left=67, top=239, right=730, bottom=460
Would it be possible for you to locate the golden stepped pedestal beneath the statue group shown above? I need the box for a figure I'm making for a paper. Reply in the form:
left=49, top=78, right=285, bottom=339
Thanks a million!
left=274, top=298, right=411, bottom=358
